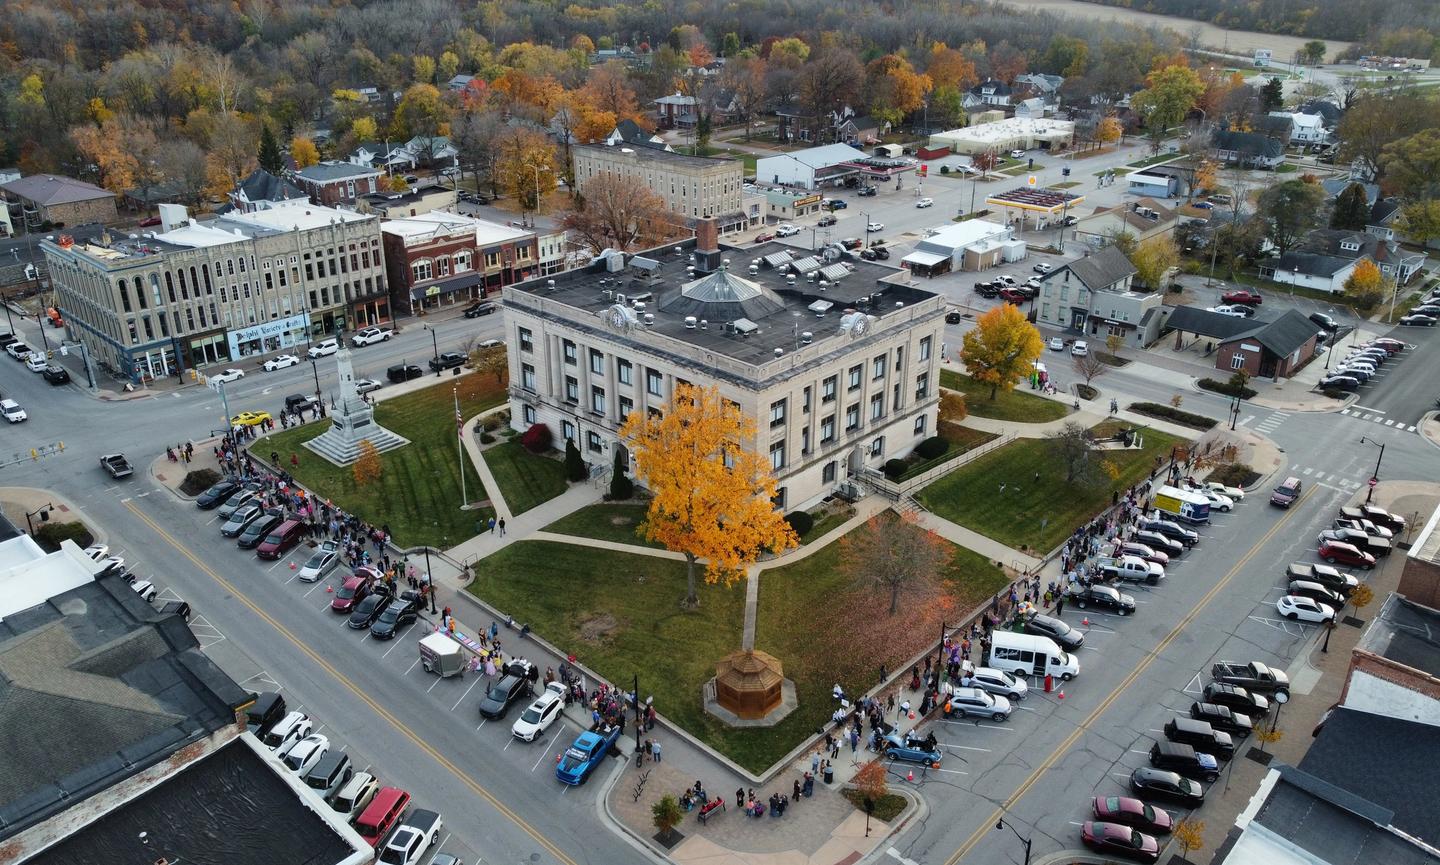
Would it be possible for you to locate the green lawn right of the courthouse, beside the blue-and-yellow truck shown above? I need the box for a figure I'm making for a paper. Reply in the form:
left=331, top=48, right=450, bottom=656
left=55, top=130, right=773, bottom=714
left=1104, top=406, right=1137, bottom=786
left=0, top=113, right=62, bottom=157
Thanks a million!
left=917, top=425, right=1182, bottom=554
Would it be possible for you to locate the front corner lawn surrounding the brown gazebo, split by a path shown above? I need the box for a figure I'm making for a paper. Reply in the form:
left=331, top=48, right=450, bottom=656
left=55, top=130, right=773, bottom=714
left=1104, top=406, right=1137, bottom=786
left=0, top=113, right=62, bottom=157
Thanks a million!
left=468, top=518, right=1005, bottom=771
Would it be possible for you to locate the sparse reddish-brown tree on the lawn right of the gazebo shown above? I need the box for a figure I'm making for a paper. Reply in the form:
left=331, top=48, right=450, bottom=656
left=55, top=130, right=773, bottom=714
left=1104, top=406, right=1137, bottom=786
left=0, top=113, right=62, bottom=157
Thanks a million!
left=840, top=512, right=955, bottom=616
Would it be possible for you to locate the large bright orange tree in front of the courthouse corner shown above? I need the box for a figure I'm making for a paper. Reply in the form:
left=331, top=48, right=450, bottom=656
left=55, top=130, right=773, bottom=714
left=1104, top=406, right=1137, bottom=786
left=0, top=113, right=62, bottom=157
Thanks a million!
left=621, top=384, right=799, bottom=607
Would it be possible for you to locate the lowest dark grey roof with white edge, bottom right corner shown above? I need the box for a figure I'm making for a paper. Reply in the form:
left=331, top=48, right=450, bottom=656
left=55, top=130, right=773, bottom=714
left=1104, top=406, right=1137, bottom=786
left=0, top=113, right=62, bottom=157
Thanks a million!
left=1225, top=764, right=1437, bottom=865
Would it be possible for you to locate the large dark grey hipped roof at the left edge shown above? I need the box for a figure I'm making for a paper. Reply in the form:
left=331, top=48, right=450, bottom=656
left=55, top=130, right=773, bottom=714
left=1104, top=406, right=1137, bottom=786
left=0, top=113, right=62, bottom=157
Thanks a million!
left=0, top=569, right=249, bottom=840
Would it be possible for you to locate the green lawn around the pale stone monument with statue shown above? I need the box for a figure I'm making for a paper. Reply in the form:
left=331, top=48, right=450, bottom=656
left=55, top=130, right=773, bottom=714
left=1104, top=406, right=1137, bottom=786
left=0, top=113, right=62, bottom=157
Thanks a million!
left=251, top=373, right=505, bottom=547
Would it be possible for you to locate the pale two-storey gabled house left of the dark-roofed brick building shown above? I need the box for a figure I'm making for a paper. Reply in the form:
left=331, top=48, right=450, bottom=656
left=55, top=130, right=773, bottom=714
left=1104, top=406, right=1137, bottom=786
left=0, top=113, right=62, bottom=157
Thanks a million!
left=1035, top=246, right=1164, bottom=348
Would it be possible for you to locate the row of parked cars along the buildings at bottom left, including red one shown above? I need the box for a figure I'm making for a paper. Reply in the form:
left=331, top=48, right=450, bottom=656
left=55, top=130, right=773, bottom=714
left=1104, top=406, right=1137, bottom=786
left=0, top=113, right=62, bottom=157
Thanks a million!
left=246, top=692, right=459, bottom=865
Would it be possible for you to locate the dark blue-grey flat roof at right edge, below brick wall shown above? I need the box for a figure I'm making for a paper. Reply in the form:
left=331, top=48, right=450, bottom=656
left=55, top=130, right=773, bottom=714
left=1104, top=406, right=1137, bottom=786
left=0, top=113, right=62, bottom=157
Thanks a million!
left=1300, top=707, right=1440, bottom=862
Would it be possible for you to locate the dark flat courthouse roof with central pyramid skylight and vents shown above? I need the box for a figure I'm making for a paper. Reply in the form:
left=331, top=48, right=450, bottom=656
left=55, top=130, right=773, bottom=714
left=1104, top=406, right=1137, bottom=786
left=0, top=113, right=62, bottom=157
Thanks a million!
left=505, top=239, right=936, bottom=364
